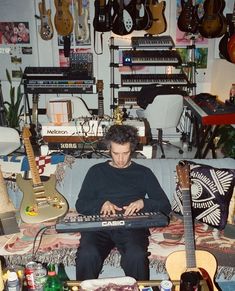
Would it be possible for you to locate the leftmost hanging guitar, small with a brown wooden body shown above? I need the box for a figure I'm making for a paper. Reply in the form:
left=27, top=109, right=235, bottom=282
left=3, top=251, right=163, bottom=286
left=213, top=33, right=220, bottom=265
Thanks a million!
left=38, top=0, right=54, bottom=40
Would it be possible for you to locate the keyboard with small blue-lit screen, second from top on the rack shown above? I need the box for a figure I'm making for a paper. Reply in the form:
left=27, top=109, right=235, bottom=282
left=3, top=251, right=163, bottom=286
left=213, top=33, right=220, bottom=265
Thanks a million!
left=122, top=50, right=182, bottom=66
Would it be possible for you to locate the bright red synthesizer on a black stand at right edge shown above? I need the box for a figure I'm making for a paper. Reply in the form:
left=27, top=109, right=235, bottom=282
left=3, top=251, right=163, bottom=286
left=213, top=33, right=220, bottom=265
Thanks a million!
left=184, top=96, right=235, bottom=125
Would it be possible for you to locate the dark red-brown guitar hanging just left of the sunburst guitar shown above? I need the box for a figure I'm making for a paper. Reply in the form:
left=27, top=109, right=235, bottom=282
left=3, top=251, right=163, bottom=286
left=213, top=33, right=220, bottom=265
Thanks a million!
left=177, top=0, right=199, bottom=33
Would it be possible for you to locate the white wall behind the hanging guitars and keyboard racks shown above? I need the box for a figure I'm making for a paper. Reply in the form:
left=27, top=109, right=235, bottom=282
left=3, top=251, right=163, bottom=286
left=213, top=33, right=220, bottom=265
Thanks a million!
left=0, top=0, right=235, bottom=123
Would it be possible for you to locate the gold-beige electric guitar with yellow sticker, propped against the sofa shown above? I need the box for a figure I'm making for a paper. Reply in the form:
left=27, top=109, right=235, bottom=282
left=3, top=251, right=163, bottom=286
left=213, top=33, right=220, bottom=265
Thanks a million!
left=16, top=127, right=68, bottom=223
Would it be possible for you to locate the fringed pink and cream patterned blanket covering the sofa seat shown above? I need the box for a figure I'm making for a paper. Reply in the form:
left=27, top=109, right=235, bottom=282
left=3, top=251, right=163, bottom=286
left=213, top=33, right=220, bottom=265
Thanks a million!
left=0, top=210, right=235, bottom=280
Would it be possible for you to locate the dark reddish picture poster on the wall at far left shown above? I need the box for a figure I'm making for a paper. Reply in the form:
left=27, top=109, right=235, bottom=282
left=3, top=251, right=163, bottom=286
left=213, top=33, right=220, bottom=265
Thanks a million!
left=0, top=22, right=30, bottom=44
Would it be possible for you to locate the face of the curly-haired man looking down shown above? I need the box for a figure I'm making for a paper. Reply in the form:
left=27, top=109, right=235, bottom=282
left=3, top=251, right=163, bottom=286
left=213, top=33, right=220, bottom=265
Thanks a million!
left=110, top=142, right=131, bottom=168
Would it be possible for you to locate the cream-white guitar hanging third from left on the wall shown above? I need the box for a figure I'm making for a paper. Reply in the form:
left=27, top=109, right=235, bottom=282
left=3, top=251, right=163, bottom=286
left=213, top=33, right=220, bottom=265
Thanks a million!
left=74, top=0, right=90, bottom=42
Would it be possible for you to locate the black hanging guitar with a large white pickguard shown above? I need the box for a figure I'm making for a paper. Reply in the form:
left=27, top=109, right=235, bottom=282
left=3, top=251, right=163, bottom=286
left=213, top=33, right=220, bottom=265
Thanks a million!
left=112, top=0, right=136, bottom=35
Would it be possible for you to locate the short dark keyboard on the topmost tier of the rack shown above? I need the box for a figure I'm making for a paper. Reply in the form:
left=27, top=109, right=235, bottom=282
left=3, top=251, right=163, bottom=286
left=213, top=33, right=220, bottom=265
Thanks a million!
left=131, top=35, right=175, bottom=49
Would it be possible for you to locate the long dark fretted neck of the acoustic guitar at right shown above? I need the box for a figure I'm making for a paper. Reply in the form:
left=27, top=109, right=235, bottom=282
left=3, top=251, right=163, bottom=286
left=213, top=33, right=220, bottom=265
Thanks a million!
left=182, top=189, right=196, bottom=268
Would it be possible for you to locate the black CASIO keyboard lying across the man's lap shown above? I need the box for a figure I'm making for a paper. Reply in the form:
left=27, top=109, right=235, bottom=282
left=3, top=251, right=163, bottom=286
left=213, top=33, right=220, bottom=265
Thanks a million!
left=55, top=212, right=169, bottom=232
